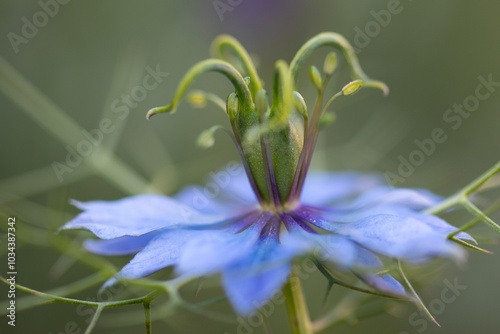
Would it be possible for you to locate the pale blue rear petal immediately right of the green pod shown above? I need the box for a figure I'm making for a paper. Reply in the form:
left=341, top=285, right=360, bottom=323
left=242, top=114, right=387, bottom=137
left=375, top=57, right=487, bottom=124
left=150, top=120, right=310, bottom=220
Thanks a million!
left=301, top=172, right=384, bottom=205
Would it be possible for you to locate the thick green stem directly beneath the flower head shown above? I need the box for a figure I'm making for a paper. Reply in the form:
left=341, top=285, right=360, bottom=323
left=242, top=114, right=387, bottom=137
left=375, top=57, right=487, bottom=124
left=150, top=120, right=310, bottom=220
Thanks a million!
left=283, top=271, right=313, bottom=334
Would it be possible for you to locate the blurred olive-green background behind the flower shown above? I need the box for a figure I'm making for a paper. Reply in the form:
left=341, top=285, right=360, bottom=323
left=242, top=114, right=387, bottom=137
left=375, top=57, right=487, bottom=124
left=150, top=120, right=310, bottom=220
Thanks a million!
left=0, top=0, right=500, bottom=334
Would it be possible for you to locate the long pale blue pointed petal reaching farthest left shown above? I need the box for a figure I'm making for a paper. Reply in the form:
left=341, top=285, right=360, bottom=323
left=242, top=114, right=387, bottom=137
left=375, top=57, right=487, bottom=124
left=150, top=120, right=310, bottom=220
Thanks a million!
left=62, top=194, right=252, bottom=239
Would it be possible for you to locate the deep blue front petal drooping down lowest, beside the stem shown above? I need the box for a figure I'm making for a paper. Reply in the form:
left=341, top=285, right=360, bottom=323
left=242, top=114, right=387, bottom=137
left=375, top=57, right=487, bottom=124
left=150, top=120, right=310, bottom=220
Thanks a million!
left=222, top=220, right=291, bottom=315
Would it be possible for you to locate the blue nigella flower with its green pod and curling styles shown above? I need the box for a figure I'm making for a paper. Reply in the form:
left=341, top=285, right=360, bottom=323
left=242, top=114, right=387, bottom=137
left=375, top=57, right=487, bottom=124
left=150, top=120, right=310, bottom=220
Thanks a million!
left=63, top=33, right=473, bottom=314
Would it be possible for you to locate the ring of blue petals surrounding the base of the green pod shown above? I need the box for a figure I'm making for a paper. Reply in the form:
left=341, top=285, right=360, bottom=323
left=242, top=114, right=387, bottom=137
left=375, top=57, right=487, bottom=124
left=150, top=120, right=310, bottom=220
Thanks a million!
left=64, top=168, right=471, bottom=314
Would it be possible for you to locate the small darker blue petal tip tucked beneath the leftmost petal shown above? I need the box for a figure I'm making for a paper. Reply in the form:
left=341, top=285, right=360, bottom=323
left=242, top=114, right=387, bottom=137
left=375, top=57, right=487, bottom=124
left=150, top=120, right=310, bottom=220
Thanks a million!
left=83, top=232, right=156, bottom=255
